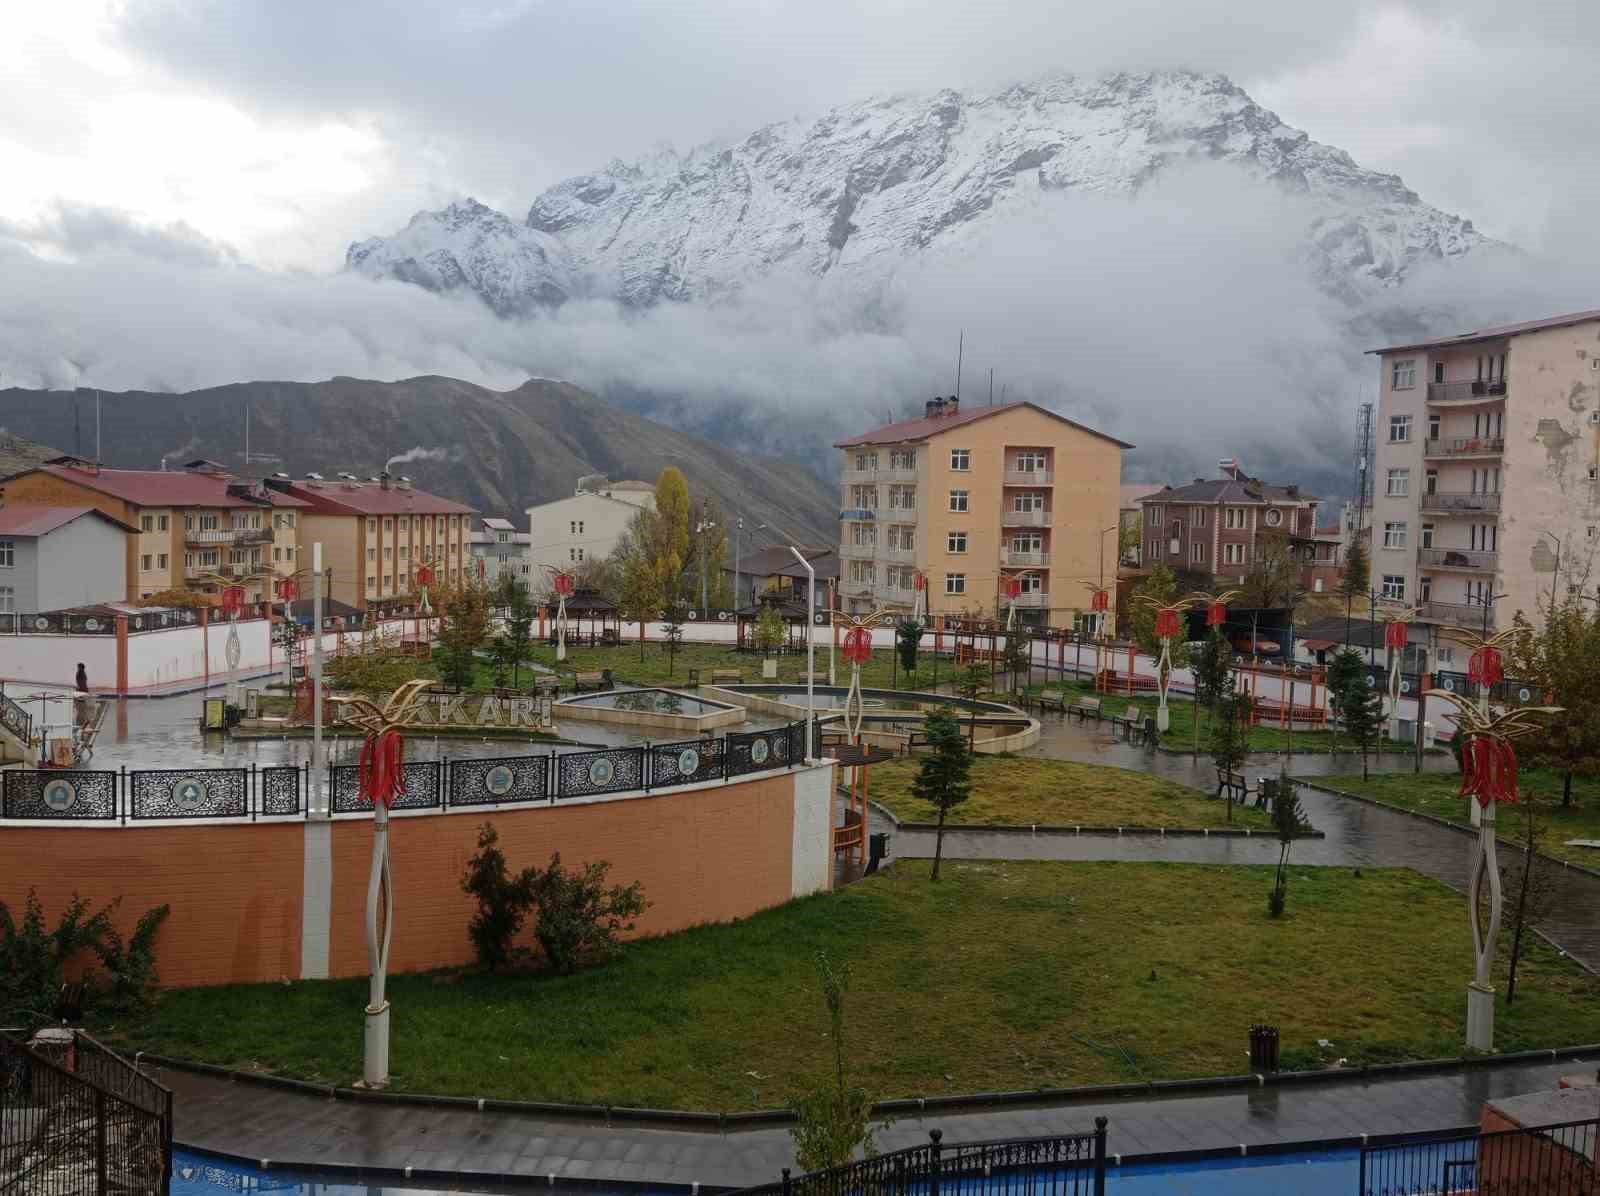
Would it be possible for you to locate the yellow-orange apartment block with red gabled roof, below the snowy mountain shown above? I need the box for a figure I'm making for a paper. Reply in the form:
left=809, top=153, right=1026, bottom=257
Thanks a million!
left=835, top=398, right=1133, bottom=627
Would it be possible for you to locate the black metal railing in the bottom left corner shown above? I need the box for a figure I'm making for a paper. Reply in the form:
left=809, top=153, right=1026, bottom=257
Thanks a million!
left=0, top=1031, right=173, bottom=1196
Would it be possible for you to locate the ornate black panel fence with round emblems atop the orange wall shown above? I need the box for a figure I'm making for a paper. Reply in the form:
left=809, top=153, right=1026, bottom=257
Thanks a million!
left=0, top=720, right=821, bottom=822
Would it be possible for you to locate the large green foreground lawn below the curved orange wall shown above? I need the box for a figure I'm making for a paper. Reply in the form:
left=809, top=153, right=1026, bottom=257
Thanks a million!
left=98, top=860, right=1600, bottom=1110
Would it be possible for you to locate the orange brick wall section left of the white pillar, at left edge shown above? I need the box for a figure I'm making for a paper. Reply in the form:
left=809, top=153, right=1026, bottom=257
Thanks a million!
left=0, top=823, right=306, bottom=985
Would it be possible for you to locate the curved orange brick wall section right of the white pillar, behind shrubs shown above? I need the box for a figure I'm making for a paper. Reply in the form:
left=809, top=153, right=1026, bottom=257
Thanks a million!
left=328, top=774, right=794, bottom=975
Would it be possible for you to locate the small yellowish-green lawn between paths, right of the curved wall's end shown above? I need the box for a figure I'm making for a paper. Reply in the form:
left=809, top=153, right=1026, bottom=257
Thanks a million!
left=870, top=755, right=1270, bottom=830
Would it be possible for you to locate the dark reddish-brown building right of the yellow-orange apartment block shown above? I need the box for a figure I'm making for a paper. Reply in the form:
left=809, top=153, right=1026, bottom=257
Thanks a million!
left=1139, top=457, right=1339, bottom=593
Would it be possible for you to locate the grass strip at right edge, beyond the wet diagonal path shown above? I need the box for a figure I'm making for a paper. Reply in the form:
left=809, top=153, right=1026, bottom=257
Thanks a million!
left=1314, top=767, right=1600, bottom=868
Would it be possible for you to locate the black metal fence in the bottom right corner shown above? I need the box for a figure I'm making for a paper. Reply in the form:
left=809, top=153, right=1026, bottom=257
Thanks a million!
left=1357, top=1119, right=1600, bottom=1196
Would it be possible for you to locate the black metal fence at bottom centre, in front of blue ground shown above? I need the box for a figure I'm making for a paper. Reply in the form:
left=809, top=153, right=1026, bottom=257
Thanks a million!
left=739, top=1118, right=1106, bottom=1196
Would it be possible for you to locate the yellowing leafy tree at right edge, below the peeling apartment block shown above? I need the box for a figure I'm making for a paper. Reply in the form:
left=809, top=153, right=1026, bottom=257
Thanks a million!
left=1507, top=598, right=1600, bottom=806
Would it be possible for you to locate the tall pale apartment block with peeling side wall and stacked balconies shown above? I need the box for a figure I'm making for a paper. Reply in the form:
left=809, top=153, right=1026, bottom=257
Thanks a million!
left=1370, top=310, right=1600, bottom=645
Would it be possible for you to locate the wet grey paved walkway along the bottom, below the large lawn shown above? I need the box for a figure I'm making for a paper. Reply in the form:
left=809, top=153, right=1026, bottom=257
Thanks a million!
left=157, top=1060, right=1600, bottom=1186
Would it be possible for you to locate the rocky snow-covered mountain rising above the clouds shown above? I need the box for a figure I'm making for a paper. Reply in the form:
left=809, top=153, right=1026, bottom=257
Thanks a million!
left=346, top=72, right=1490, bottom=315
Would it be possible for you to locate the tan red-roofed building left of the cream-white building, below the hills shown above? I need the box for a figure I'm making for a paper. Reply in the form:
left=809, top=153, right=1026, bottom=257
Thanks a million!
left=267, top=473, right=477, bottom=611
